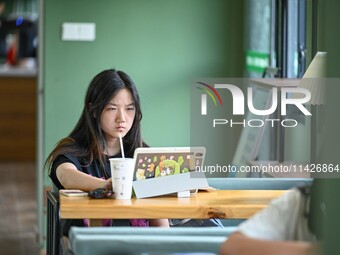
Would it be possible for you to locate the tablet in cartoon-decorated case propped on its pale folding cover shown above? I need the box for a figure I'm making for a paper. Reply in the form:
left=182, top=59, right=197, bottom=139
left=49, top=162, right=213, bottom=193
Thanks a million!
left=133, top=147, right=209, bottom=198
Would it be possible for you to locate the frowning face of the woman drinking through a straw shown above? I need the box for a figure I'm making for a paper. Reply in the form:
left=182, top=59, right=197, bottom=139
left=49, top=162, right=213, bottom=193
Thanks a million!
left=100, top=89, right=136, bottom=141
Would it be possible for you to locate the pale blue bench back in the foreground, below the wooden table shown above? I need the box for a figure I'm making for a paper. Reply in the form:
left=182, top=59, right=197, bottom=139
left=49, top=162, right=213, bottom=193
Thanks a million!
left=69, top=227, right=236, bottom=255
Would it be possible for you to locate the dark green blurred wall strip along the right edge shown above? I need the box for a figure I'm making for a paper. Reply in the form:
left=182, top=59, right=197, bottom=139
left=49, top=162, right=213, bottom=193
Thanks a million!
left=318, top=0, right=340, bottom=255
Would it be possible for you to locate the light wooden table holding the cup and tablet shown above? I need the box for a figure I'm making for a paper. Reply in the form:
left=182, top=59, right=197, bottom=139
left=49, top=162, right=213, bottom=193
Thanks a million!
left=60, top=190, right=286, bottom=219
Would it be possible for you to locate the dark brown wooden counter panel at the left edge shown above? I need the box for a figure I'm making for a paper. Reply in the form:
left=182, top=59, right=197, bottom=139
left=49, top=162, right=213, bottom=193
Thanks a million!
left=0, top=77, right=37, bottom=162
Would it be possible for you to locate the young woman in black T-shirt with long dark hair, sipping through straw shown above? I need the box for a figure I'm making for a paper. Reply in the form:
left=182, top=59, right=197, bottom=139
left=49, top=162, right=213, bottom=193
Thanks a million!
left=46, top=69, right=169, bottom=235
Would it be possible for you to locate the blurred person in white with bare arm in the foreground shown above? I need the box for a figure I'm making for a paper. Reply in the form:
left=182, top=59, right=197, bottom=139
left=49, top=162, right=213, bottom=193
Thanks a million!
left=220, top=181, right=326, bottom=255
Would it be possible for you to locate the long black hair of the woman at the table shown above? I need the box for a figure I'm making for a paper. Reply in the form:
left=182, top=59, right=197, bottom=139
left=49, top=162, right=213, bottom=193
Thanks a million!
left=46, top=69, right=142, bottom=168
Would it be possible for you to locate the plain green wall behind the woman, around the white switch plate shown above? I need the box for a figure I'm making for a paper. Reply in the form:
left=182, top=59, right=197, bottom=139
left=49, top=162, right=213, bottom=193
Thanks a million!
left=43, top=0, right=243, bottom=171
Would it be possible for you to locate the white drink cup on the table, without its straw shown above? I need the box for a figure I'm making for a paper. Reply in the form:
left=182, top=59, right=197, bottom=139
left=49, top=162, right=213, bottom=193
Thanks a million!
left=110, top=158, right=135, bottom=199
